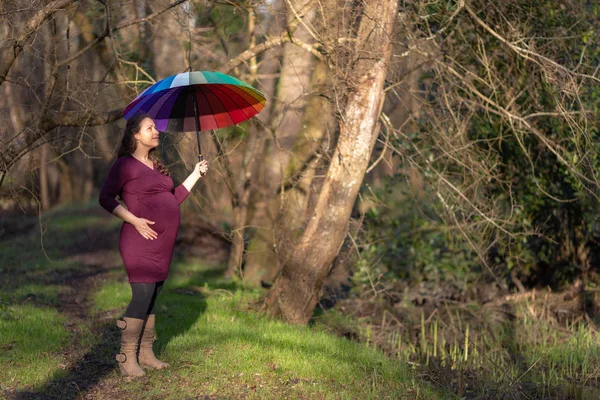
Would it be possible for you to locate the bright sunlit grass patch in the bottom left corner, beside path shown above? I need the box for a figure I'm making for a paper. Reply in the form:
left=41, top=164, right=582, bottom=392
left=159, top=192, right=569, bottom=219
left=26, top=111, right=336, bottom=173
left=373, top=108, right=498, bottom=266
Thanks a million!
left=0, top=304, right=70, bottom=390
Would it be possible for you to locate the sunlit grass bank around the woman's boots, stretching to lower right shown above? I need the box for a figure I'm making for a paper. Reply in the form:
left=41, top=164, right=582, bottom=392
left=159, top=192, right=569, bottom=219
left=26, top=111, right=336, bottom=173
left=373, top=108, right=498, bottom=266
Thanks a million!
left=95, top=261, right=439, bottom=399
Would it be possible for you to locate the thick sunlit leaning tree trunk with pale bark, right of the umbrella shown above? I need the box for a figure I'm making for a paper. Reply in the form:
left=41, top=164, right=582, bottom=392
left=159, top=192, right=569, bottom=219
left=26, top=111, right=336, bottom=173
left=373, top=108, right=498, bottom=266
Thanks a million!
left=264, top=0, right=397, bottom=324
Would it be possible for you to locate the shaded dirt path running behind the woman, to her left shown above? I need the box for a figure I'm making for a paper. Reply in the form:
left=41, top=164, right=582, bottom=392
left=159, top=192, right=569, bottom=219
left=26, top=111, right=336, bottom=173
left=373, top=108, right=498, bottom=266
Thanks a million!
left=10, top=211, right=136, bottom=400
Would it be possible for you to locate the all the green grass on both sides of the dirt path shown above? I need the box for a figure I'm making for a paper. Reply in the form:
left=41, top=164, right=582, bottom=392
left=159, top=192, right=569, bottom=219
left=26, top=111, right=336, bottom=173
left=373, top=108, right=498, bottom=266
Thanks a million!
left=0, top=202, right=445, bottom=399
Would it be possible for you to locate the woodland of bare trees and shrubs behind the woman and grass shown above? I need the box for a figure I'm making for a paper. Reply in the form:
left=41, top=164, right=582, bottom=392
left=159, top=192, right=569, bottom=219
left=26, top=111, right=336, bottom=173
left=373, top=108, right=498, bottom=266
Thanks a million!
left=0, top=0, right=600, bottom=398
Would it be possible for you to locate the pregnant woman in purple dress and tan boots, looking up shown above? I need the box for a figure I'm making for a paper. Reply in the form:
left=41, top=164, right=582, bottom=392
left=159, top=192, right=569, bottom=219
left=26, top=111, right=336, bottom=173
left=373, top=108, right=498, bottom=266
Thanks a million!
left=98, top=115, right=208, bottom=376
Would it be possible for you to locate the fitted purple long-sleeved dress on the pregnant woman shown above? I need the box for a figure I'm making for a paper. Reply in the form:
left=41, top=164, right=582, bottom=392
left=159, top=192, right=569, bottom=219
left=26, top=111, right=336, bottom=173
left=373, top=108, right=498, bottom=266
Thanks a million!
left=98, top=155, right=189, bottom=282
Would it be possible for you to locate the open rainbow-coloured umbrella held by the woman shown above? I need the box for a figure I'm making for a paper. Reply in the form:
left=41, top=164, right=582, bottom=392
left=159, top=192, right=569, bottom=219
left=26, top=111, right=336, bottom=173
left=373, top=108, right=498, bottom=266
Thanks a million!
left=123, top=71, right=266, bottom=161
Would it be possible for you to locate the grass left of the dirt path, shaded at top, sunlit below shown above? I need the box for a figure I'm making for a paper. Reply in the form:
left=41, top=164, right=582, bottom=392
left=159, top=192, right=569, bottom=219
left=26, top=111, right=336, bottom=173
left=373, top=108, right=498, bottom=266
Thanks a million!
left=0, top=206, right=89, bottom=390
